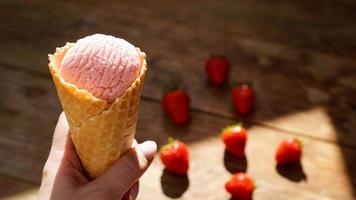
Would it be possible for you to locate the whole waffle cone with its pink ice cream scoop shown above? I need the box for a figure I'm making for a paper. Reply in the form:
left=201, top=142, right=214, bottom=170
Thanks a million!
left=48, top=34, right=147, bottom=179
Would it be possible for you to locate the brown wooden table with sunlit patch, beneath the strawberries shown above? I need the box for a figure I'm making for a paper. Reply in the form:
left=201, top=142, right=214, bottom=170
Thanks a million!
left=0, top=0, right=356, bottom=200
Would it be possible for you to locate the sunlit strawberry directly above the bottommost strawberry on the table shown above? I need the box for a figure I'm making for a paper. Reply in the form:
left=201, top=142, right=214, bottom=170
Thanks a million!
left=221, top=124, right=247, bottom=157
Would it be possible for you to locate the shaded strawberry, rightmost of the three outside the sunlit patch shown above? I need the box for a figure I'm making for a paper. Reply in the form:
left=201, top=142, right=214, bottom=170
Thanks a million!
left=231, top=84, right=254, bottom=115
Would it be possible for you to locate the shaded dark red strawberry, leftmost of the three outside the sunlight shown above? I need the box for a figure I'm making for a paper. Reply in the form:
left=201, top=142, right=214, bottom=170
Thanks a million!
left=162, top=89, right=190, bottom=124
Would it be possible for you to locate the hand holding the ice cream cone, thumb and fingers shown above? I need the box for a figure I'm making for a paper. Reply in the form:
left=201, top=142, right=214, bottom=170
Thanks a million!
left=39, top=113, right=157, bottom=200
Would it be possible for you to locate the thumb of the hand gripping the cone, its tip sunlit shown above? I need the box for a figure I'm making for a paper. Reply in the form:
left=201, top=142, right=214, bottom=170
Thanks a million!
left=88, top=141, right=157, bottom=199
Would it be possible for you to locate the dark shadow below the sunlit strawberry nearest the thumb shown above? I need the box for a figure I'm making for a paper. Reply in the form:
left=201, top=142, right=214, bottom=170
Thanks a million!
left=161, top=170, right=189, bottom=198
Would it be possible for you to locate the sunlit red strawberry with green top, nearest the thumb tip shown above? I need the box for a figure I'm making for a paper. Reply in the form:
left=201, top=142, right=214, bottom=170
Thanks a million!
left=160, top=138, right=189, bottom=175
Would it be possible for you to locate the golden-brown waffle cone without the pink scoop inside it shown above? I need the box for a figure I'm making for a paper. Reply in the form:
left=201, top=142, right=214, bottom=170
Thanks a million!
left=49, top=43, right=147, bottom=179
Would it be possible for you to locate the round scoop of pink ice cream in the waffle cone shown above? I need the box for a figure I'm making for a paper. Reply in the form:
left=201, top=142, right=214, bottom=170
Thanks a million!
left=59, top=34, right=141, bottom=103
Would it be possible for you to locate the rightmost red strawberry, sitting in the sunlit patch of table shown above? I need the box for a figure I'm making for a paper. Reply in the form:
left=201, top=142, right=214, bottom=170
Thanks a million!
left=276, top=138, right=302, bottom=164
